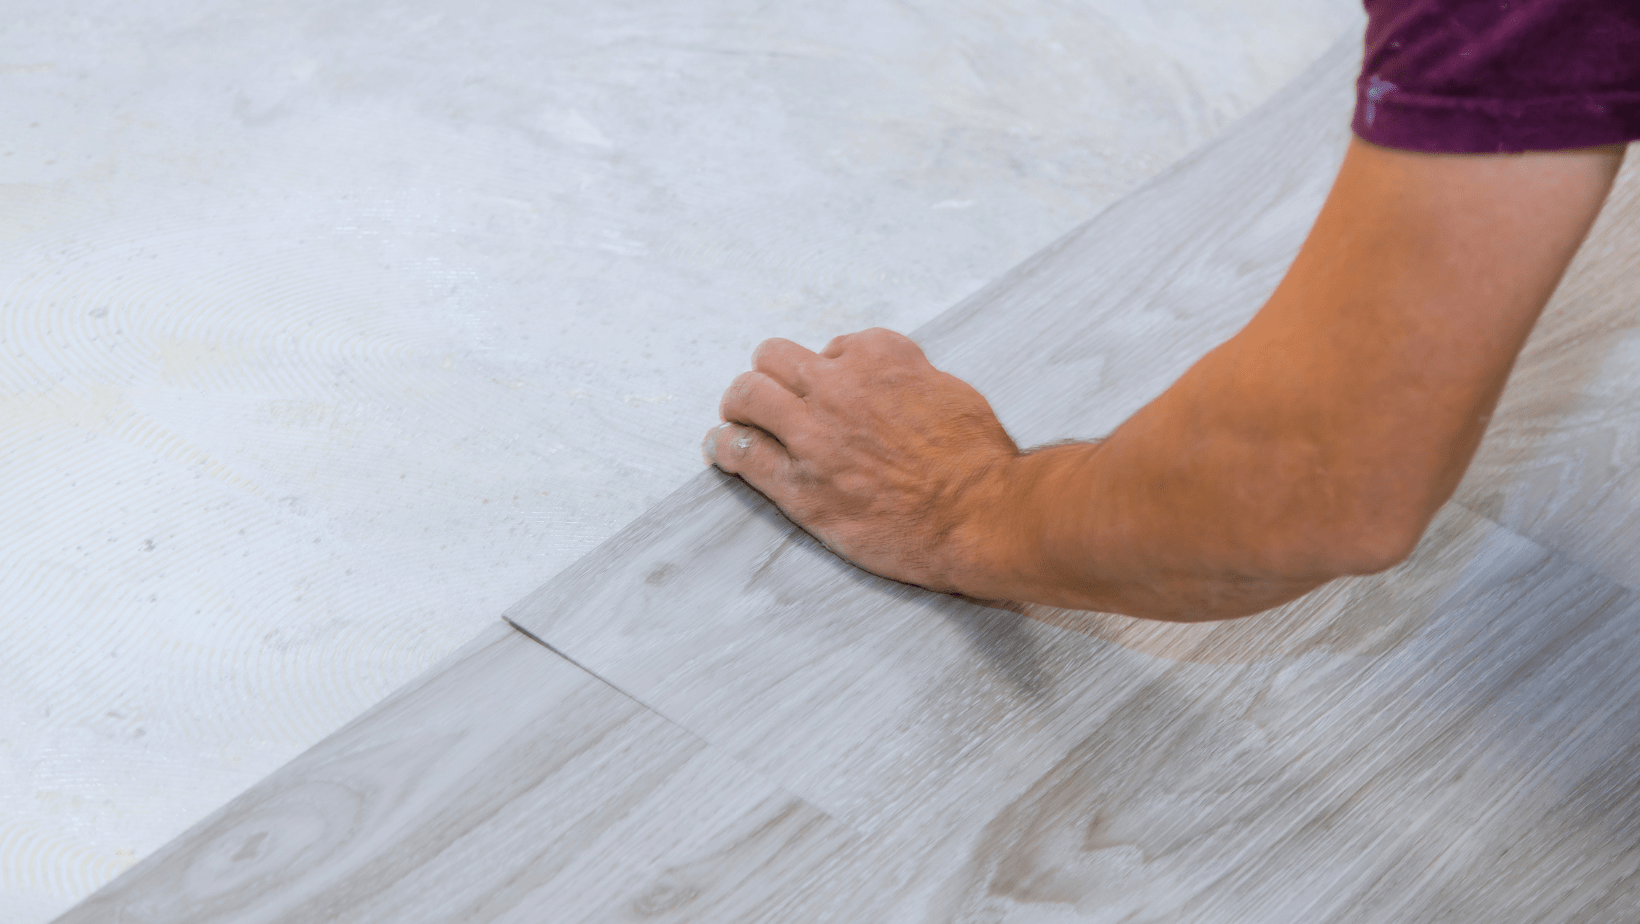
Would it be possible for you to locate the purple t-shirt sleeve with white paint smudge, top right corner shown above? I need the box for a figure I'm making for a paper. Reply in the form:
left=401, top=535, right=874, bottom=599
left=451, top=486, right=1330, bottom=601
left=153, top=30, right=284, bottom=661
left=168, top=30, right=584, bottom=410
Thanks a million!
left=1355, top=0, right=1640, bottom=153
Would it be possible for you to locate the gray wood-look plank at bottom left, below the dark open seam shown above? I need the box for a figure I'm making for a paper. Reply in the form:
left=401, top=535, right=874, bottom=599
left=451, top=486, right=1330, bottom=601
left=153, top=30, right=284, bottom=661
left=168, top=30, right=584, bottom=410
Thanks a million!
left=59, top=624, right=851, bottom=924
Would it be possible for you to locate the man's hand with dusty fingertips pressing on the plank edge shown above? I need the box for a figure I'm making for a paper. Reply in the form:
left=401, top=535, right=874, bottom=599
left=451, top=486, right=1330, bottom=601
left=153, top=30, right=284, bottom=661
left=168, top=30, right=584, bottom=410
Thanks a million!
left=702, top=328, right=1020, bottom=592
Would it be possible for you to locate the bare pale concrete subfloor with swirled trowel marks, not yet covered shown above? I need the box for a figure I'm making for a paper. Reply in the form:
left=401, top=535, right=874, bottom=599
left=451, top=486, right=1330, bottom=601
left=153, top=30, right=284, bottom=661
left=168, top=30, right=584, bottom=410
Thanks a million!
left=0, top=0, right=1360, bottom=924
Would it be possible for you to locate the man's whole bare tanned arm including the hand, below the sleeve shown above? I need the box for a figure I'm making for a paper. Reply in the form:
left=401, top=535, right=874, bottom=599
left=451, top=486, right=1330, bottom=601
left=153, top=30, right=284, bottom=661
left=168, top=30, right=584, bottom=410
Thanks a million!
left=705, top=140, right=1622, bottom=622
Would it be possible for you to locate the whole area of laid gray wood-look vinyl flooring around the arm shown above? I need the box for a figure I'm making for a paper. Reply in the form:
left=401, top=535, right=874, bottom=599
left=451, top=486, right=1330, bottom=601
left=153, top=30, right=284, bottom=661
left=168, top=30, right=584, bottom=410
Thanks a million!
left=62, top=43, right=1640, bottom=924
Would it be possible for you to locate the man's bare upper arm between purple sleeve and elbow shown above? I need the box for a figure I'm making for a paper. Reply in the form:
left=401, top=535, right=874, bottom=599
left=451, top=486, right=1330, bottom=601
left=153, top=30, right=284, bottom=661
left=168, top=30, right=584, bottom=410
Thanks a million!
left=1200, top=140, right=1622, bottom=569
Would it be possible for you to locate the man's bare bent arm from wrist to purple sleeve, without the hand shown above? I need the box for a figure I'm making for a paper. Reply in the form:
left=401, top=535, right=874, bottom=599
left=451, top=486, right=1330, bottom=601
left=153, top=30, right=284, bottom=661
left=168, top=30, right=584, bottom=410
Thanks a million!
left=959, top=143, right=1619, bottom=620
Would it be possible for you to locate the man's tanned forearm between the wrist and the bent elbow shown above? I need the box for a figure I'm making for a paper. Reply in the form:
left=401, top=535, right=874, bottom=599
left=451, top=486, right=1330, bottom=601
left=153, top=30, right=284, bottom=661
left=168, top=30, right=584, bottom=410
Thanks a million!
left=953, top=343, right=1403, bottom=620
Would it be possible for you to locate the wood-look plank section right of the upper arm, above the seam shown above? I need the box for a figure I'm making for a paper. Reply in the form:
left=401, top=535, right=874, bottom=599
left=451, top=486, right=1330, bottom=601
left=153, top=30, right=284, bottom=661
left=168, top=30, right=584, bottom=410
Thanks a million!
left=1458, top=146, right=1640, bottom=588
